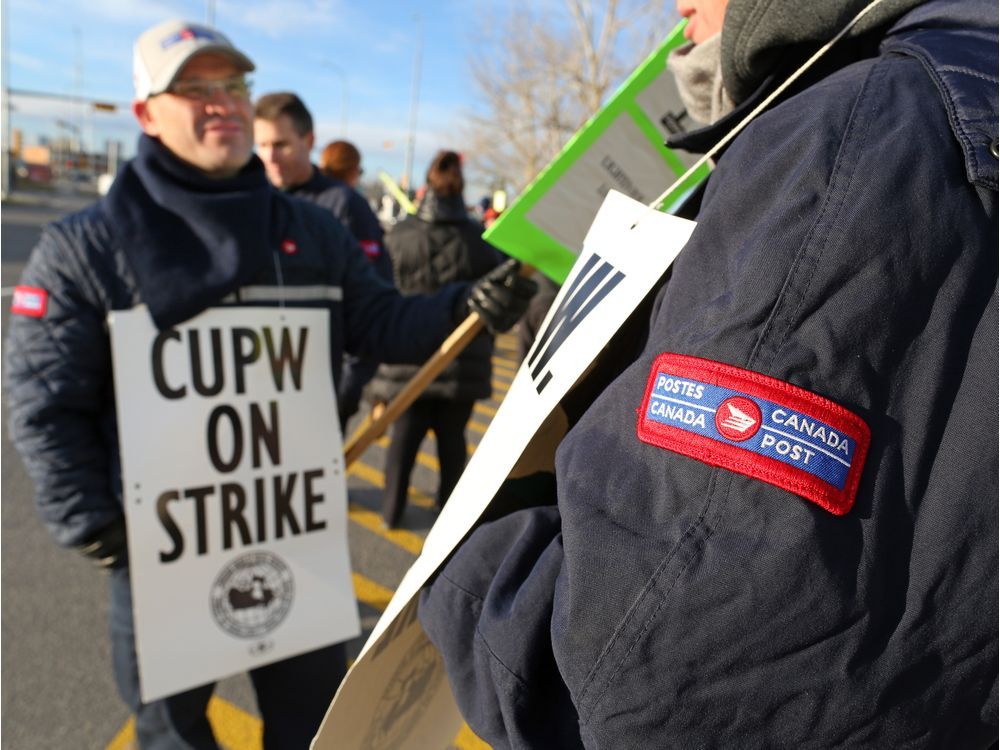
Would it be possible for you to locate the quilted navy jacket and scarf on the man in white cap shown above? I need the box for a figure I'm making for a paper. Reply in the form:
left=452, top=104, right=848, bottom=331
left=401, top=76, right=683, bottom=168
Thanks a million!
left=4, top=136, right=466, bottom=546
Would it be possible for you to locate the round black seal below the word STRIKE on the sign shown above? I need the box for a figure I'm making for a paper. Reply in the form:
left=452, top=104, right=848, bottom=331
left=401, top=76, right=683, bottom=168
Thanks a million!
left=210, top=552, right=295, bottom=638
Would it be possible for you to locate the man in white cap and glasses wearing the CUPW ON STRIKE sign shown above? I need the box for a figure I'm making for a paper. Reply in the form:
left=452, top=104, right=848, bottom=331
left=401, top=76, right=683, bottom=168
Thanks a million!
left=5, top=21, right=530, bottom=749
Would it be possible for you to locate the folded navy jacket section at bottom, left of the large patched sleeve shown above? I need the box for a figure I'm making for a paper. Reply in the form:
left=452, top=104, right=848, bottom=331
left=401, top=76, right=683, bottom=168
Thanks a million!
left=419, top=506, right=582, bottom=750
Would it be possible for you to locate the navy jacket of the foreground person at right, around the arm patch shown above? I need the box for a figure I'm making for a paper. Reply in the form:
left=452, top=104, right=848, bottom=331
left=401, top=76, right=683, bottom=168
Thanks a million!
left=420, top=0, right=998, bottom=750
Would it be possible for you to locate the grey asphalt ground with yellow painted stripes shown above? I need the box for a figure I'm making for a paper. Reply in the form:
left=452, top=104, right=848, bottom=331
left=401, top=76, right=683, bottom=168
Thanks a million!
left=0, top=196, right=516, bottom=750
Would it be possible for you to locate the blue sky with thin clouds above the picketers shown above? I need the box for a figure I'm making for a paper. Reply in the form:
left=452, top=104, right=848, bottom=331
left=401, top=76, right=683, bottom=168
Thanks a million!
left=4, top=0, right=505, bottom=200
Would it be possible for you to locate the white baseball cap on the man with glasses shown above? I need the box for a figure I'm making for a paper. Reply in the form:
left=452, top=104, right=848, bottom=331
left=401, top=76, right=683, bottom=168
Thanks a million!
left=132, top=20, right=254, bottom=101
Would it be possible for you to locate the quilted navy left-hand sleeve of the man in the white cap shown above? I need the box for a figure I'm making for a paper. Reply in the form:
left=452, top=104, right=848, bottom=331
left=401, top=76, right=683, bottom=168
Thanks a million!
left=4, top=222, right=122, bottom=546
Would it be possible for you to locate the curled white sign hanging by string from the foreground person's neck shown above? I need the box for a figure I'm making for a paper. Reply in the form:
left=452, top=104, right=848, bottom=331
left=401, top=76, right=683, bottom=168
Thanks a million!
left=312, top=191, right=695, bottom=750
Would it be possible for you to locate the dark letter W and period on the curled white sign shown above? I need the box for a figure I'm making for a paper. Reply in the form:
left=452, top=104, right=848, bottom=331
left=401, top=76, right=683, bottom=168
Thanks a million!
left=528, top=255, right=625, bottom=393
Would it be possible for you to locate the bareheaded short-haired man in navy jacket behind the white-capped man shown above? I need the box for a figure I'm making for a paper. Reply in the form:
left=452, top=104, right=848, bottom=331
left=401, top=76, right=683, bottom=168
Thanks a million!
left=253, top=91, right=392, bottom=432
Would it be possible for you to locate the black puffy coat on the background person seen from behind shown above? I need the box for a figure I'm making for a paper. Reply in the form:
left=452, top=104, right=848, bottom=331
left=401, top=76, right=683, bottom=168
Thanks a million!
left=370, top=190, right=501, bottom=401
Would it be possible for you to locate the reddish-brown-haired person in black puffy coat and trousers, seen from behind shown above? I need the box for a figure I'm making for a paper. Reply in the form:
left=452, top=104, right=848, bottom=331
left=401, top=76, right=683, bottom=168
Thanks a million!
left=371, top=151, right=500, bottom=528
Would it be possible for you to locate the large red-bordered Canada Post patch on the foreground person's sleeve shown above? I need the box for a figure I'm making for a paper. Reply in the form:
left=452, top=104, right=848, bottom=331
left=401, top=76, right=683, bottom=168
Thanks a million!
left=638, top=352, right=871, bottom=516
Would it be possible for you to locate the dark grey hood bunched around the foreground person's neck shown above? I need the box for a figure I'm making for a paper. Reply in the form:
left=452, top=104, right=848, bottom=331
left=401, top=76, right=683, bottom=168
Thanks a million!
left=722, top=0, right=925, bottom=104
